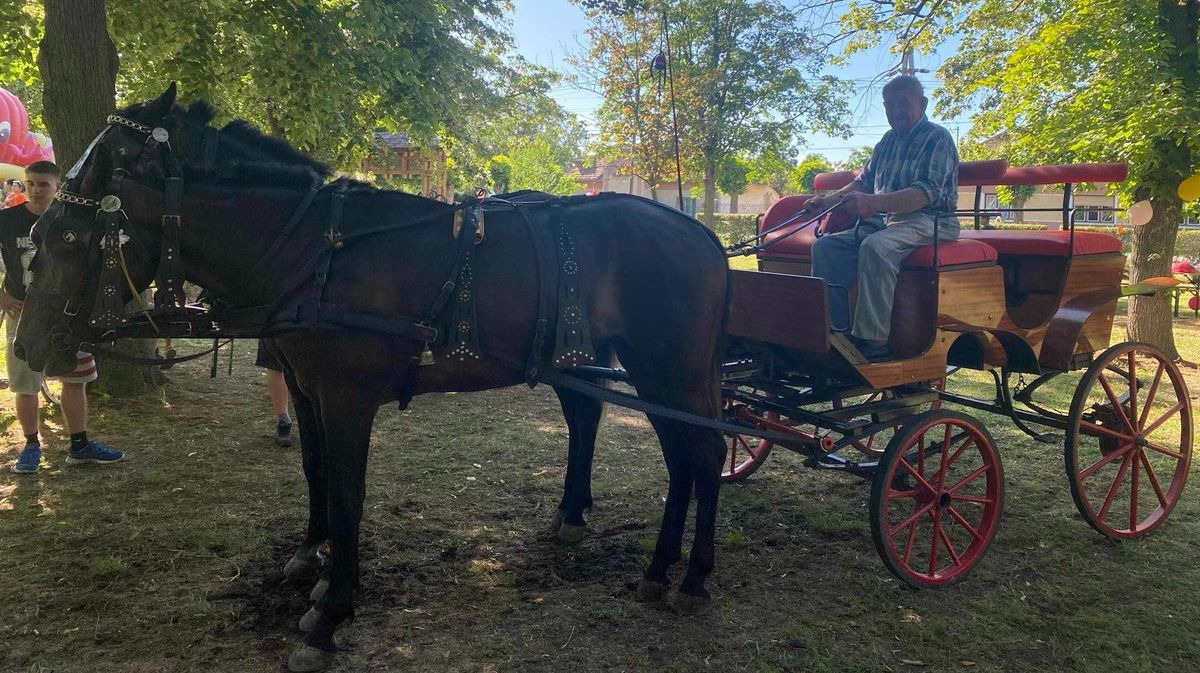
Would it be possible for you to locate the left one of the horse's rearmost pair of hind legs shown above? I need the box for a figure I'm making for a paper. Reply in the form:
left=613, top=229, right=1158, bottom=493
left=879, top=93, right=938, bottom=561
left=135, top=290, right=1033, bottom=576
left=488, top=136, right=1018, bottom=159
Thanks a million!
left=637, top=416, right=692, bottom=601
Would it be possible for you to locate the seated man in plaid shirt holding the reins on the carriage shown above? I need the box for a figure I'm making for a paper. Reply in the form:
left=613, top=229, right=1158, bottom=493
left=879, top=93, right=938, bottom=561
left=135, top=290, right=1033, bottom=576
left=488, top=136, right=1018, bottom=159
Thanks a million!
left=806, top=76, right=959, bottom=361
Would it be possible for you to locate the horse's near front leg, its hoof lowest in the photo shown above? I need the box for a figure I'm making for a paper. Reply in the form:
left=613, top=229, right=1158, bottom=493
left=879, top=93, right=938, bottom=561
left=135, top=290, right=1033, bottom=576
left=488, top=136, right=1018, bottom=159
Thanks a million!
left=288, top=392, right=377, bottom=672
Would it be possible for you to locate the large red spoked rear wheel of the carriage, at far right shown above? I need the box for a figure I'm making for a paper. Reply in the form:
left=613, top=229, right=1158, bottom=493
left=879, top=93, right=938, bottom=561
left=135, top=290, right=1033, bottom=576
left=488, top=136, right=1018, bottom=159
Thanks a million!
left=1066, top=342, right=1192, bottom=540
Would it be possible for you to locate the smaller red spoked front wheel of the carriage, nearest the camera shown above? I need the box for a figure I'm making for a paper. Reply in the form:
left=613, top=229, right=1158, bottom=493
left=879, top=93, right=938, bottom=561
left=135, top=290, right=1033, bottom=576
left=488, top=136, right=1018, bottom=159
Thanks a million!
left=870, top=410, right=1004, bottom=588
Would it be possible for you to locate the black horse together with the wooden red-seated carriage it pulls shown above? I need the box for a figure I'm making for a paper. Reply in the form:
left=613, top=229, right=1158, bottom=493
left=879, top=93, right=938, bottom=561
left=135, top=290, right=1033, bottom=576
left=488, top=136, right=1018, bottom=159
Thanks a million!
left=14, top=86, right=1192, bottom=671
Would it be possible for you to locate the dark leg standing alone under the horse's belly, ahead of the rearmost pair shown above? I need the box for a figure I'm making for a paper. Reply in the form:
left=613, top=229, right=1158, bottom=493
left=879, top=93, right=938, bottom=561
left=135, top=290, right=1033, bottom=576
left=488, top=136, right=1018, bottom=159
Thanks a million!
left=552, top=387, right=604, bottom=545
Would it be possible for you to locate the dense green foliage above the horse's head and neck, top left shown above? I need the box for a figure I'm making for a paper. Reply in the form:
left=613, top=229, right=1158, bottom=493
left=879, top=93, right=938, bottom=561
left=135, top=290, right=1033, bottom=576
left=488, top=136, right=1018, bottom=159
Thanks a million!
left=0, top=0, right=561, bottom=170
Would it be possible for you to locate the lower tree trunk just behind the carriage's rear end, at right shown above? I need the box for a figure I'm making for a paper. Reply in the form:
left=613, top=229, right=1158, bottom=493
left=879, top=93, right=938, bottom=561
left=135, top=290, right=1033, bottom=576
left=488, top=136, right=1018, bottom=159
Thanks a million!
left=1127, top=188, right=1183, bottom=359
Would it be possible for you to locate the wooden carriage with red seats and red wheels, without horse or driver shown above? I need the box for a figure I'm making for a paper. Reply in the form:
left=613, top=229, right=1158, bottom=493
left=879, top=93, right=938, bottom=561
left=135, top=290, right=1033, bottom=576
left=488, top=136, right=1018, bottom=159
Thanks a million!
left=722, top=161, right=1192, bottom=587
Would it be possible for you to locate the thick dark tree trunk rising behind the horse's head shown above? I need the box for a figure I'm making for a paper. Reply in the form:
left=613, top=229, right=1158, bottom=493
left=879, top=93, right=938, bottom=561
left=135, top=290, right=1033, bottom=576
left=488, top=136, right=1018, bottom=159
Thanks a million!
left=37, top=0, right=118, bottom=169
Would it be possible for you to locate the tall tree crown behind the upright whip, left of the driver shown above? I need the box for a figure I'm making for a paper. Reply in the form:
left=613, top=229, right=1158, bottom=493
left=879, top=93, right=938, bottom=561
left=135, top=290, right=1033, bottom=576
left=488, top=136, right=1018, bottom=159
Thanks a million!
left=578, top=0, right=846, bottom=220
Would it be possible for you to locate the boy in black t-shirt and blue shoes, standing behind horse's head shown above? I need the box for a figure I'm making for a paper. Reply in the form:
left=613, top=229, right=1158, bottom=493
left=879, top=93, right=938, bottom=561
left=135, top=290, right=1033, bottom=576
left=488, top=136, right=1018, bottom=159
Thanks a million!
left=0, top=161, right=125, bottom=473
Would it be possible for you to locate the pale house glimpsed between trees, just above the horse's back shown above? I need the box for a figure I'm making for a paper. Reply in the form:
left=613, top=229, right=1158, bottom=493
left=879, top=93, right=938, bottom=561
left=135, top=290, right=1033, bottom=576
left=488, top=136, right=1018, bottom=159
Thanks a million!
left=568, top=158, right=780, bottom=215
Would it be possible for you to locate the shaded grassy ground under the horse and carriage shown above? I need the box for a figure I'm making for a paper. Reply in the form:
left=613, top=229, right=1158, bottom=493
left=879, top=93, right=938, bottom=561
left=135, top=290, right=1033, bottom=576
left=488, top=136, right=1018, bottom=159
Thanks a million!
left=0, top=314, right=1200, bottom=673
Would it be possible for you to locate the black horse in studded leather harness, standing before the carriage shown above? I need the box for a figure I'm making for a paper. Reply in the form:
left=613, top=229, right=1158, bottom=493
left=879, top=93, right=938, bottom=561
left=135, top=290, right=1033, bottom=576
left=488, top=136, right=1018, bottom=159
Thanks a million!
left=17, top=85, right=728, bottom=671
